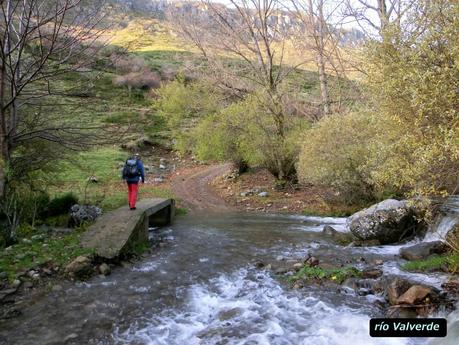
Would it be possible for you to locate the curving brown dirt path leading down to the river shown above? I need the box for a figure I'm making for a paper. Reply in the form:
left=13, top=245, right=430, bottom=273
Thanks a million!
left=172, top=164, right=232, bottom=211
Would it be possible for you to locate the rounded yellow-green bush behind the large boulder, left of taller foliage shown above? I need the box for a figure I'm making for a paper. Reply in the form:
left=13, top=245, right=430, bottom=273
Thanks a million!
left=299, top=112, right=397, bottom=203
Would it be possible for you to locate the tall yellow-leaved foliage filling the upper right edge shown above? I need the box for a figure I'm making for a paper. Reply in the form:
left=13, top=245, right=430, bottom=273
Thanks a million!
left=367, top=1, right=459, bottom=194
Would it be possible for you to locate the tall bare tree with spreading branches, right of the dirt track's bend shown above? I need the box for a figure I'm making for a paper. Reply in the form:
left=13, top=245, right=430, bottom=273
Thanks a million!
left=169, top=0, right=302, bottom=179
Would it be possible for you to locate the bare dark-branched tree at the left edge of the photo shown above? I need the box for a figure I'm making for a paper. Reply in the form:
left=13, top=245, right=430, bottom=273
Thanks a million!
left=0, top=0, right=109, bottom=196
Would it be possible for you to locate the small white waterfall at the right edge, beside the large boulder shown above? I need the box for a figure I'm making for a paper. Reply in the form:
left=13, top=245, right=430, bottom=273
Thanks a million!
left=424, top=195, right=459, bottom=242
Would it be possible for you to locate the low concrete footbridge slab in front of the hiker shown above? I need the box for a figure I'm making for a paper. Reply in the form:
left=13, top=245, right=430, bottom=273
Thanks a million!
left=81, top=199, right=175, bottom=260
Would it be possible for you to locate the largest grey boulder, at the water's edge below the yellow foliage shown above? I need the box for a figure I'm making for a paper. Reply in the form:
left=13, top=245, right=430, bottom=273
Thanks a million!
left=347, top=199, right=426, bottom=244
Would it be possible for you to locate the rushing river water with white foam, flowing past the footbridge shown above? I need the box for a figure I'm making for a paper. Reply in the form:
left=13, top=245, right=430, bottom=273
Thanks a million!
left=0, top=214, right=458, bottom=345
